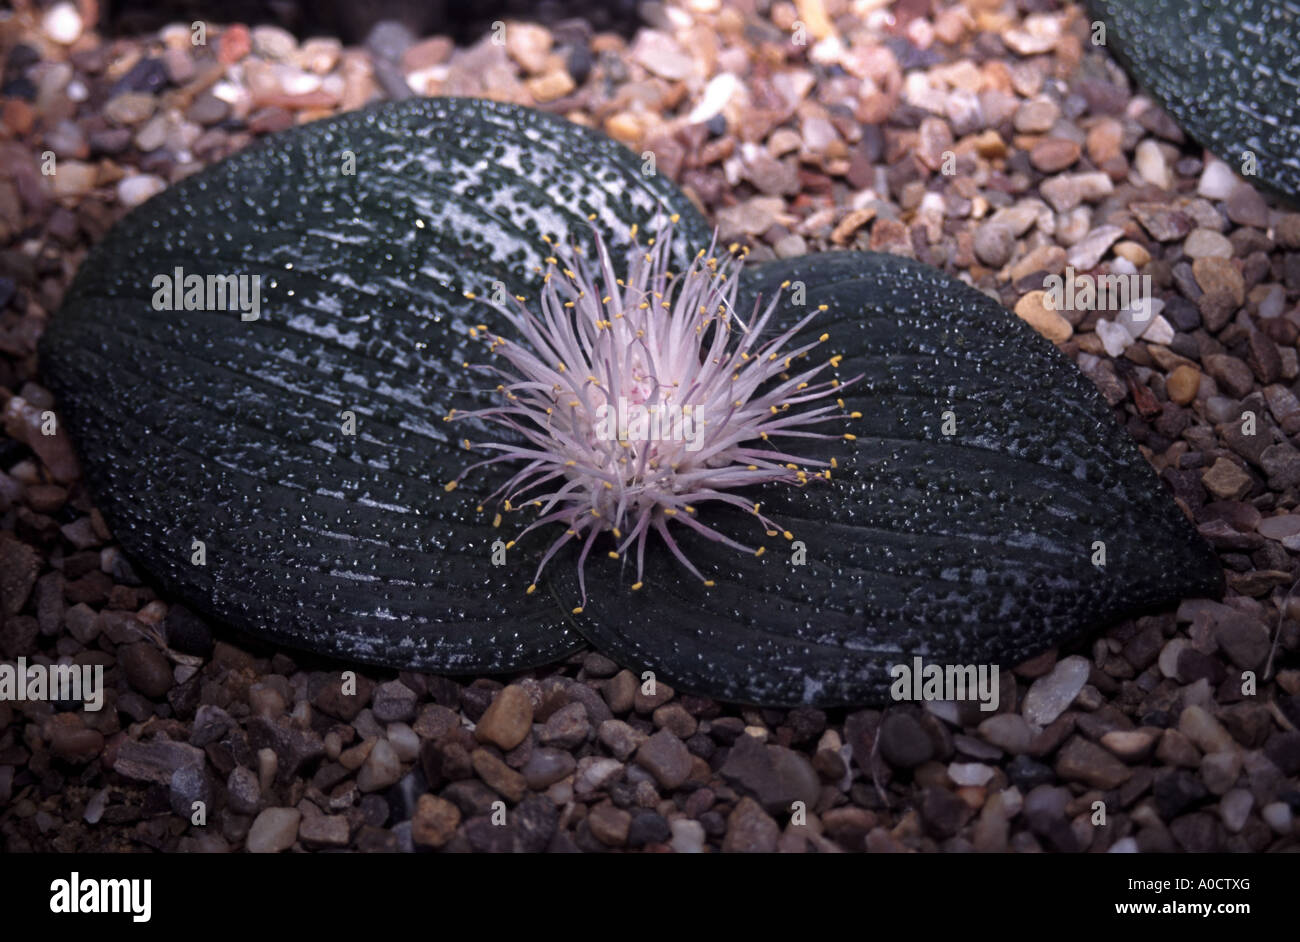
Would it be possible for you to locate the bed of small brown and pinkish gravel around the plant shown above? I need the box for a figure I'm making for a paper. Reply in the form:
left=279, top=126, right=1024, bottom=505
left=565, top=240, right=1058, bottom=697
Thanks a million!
left=0, top=0, right=1300, bottom=852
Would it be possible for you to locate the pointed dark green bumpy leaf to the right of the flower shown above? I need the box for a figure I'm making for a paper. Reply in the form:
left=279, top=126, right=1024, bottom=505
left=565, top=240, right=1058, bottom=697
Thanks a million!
left=564, top=252, right=1223, bottom=706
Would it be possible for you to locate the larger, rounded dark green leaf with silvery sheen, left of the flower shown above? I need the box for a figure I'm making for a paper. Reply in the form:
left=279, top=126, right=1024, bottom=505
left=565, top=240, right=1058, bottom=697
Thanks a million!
left=42, top=99, right=709, bottom=670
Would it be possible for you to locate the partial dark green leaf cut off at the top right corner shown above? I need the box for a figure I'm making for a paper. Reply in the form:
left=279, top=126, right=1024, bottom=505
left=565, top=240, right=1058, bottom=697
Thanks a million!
left=1088, top=0, right=1300, bottom=199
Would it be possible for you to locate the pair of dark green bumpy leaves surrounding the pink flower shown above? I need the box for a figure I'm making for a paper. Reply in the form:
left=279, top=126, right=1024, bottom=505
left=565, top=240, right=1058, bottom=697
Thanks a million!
left=42, top=100, right=1222, bottom=706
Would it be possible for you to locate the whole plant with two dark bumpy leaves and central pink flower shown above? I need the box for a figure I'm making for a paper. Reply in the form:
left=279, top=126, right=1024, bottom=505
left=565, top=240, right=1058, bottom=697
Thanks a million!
left=42, top=99, right=1222, bottom=704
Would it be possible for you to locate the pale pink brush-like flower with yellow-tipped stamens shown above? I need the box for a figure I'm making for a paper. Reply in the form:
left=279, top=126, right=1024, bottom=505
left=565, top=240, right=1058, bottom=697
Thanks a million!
left=446, top=217, right=859, bottom=613
